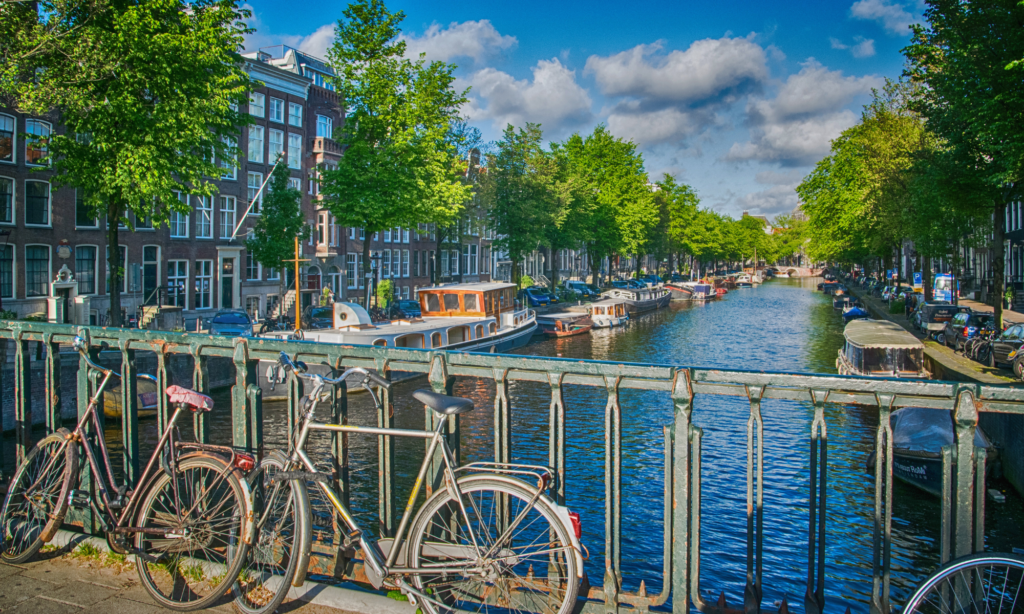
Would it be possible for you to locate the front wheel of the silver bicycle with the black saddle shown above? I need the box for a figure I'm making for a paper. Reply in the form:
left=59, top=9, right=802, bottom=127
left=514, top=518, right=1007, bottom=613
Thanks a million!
left=231, top=452, right=312, bottom=614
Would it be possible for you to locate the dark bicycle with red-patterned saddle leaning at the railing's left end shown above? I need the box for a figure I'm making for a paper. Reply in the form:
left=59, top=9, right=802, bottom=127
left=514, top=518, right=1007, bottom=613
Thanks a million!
left=0, top=337, right=255, bottom=611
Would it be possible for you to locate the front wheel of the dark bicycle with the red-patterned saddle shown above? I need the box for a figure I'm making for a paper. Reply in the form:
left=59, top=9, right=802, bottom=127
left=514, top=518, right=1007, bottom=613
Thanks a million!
left=0, top=429, right=78, bottom=564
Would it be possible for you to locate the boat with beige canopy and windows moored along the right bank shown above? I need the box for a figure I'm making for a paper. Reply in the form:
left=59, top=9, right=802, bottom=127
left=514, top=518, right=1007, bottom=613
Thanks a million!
left=836, top=319, right=931, bottom=380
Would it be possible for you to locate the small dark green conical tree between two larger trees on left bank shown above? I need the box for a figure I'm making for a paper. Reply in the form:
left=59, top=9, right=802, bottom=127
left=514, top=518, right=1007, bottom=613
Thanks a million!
left=246, top=157, right=309, bottom=321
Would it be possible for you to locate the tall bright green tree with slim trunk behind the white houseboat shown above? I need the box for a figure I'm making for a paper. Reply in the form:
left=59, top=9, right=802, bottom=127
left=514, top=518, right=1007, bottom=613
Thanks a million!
left=321, top=0, right=471, bottom=305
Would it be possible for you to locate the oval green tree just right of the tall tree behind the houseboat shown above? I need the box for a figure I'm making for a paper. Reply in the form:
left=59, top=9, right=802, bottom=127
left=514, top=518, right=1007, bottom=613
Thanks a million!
left=480, top=124, right=557, bottom=283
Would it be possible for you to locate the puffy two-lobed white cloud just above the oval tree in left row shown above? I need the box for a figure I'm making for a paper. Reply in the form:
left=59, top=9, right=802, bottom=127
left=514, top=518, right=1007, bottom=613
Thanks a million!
left=466, top=57, right=593, bottom=138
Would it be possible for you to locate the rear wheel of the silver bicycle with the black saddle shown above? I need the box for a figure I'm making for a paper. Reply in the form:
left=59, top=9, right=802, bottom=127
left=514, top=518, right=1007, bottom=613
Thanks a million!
left=409, top=476, right=580, bottom=614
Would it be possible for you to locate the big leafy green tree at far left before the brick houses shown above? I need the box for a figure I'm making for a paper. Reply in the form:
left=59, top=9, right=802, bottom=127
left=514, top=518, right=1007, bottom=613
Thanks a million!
left=0, top=0, right=253, bottom=325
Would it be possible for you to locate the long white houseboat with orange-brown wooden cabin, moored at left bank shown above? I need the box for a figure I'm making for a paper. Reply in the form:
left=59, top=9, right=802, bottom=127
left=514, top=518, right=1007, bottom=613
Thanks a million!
left=271, top=282, right=537, bottom=352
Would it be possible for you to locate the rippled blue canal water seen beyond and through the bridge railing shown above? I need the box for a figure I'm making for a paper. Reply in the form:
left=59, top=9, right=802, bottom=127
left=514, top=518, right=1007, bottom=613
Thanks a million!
left=7, top=279, right=1024, bottom=612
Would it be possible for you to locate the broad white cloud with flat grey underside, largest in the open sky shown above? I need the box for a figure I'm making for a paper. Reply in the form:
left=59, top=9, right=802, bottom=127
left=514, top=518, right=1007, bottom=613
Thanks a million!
left=585, top=36, right=768, bottom=102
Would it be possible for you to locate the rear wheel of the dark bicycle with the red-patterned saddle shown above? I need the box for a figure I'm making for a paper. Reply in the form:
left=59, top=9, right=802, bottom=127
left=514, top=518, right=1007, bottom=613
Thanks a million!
left=135, top=455, right=249, bottom=612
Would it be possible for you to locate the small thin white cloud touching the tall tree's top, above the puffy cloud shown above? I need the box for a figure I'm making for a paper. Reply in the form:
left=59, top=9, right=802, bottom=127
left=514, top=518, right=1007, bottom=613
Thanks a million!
left=401, top=19, right=519, bottom=61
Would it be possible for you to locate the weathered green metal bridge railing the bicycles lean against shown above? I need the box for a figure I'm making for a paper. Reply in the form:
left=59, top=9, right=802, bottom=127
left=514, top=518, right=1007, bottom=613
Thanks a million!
left=0, top=321, right=1024, bottom=614
